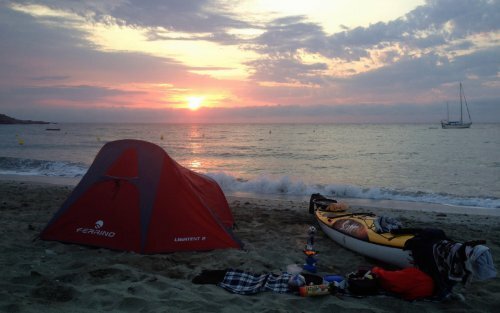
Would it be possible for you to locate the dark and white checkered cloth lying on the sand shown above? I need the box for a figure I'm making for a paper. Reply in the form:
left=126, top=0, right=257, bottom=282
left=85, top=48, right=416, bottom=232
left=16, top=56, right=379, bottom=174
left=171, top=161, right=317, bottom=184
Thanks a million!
left=219, top=269, right=292, bottom=295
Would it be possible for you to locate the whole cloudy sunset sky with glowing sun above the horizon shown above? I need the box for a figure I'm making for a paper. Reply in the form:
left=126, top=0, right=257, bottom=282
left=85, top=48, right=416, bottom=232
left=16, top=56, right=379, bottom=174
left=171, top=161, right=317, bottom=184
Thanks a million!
left=0, top=0, right=500, bottom=123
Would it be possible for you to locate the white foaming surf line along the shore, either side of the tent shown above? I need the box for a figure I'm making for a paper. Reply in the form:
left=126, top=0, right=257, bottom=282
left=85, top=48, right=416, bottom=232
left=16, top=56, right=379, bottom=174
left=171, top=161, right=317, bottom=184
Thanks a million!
left=0, top=157, right=500, bottom=209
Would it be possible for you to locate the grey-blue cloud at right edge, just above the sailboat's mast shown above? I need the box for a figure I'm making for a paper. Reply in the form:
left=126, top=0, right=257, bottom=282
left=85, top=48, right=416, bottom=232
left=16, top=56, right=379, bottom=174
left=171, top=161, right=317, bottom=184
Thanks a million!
left=336, top=47, right=500, bottom=103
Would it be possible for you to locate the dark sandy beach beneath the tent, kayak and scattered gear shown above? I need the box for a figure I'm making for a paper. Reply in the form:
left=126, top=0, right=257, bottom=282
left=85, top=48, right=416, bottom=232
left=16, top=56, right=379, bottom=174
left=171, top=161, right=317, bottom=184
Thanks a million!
left=0, top=180, right=500, bottom=313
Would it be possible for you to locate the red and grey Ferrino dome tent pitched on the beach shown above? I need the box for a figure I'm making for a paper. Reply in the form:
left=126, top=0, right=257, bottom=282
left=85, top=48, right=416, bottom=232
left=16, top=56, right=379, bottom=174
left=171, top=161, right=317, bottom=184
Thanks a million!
left=40, top=140, right=242, bottom=253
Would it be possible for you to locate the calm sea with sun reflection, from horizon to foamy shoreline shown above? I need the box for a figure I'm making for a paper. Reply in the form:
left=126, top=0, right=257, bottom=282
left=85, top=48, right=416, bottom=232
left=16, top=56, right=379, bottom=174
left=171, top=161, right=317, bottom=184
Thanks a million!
left=0, top=124, right=500, bottom=209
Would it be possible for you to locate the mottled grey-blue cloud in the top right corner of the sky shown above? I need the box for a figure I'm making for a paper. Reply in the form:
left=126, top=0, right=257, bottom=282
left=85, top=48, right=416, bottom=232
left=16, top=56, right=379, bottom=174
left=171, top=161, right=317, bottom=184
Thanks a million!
left=321, top=0, right=500, bottom=55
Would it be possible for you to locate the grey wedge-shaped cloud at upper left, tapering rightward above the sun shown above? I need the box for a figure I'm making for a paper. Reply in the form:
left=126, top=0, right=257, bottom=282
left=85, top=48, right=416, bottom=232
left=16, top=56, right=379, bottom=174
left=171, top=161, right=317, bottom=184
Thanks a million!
left=0, top=10, right=184, bottom=85
